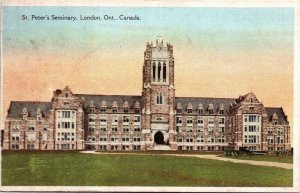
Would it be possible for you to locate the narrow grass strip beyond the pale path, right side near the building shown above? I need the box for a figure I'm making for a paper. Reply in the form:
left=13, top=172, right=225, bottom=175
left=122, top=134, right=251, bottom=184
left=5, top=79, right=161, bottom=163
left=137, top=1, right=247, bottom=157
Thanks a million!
left=220, top=155, right=293, bottom=163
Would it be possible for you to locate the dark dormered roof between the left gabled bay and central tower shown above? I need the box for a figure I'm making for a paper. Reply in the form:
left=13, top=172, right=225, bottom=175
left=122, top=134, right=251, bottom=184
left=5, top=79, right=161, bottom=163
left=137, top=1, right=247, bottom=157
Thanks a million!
left=77, top=94, right=142, bottom=108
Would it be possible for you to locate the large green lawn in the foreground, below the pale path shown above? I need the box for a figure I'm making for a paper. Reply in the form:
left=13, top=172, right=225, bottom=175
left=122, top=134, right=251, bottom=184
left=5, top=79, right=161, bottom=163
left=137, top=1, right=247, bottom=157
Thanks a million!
left=2, top=152, right=292, bottom=187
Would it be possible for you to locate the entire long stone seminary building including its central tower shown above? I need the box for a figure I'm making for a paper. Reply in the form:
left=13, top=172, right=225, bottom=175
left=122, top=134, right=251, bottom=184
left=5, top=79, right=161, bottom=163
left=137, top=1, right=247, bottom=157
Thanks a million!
left=3, top=38, right=290, bottom=151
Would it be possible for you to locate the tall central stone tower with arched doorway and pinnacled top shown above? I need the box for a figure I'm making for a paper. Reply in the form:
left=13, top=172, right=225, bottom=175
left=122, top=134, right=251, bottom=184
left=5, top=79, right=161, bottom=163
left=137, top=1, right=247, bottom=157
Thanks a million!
left=142, top=36, right=175, bottom=150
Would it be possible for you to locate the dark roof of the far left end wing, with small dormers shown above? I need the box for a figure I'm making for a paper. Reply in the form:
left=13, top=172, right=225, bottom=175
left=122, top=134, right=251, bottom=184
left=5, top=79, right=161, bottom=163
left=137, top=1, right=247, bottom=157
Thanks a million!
left=7, top=101, right=52, bottom=117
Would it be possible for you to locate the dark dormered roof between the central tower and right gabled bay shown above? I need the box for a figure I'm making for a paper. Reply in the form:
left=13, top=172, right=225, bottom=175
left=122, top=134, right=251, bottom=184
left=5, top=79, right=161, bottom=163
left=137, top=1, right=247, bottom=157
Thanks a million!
left=175, top=97, right=235, bottom=109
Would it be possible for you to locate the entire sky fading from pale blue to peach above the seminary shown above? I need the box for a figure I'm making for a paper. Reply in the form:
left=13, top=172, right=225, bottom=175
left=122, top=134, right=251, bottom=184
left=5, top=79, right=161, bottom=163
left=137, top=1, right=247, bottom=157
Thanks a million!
left=2, top=6, right=294, bottom=142
